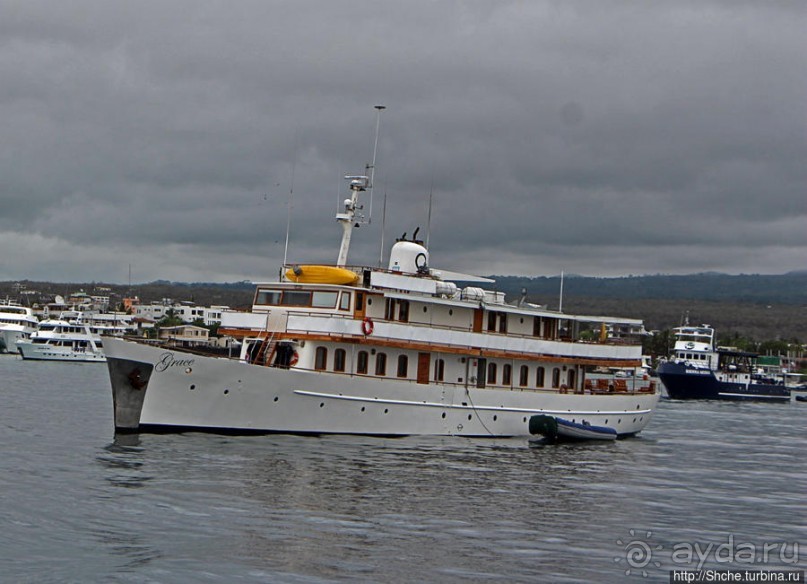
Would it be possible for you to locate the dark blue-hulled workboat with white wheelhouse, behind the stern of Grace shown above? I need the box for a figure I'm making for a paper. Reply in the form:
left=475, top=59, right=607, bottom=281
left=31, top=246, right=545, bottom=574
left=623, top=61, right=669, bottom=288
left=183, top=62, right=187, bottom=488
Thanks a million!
left=657, top=325, right=790, bottom=402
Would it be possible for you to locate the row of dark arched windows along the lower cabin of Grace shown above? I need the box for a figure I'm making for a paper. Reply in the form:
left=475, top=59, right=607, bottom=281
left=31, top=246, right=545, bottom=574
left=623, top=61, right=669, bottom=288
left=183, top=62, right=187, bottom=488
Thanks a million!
left=314, top=347, right=576, bottom=389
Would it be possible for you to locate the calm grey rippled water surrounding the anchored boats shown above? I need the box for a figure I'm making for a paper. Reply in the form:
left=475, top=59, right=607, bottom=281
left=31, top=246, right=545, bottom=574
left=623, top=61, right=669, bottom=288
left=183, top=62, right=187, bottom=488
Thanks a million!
left=0, top=356, right=807, bottom=583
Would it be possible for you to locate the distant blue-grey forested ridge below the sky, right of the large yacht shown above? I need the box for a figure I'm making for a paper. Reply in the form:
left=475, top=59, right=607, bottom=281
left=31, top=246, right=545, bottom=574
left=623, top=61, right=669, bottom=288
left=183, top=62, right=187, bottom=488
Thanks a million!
left=492, top=272, right=807, bottom=305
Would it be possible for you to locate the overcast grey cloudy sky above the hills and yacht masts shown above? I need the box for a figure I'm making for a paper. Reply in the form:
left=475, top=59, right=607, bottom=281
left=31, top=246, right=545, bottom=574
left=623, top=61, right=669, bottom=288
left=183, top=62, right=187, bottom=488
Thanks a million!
left=0, top=0, right=807, bottom=283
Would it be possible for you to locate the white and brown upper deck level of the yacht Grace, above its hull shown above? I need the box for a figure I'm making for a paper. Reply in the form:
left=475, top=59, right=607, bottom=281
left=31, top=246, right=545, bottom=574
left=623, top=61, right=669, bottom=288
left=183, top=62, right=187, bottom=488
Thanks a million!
left=220, top=268, right=645, bottom=366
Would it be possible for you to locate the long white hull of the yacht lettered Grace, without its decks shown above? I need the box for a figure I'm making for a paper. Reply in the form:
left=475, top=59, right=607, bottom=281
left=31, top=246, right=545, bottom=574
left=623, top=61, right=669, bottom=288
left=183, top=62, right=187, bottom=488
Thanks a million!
left=103, top=337, right=658, bottom=437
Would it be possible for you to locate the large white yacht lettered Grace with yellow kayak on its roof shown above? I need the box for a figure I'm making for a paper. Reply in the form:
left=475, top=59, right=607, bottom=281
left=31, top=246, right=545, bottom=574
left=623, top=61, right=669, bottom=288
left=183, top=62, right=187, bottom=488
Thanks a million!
left=103, top=167, right=659, bottom=437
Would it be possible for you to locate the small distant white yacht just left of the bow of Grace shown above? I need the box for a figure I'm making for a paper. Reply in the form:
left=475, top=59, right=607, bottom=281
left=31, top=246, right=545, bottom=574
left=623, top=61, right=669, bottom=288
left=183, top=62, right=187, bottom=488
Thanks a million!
left=17, top=319, right=106, bottom=363
